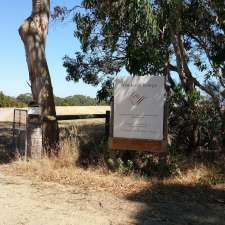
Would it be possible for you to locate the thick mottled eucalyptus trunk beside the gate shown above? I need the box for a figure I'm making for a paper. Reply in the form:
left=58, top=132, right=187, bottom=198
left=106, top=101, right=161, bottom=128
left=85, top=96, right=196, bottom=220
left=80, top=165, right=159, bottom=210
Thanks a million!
left=19, top=0, right=58, bottom=152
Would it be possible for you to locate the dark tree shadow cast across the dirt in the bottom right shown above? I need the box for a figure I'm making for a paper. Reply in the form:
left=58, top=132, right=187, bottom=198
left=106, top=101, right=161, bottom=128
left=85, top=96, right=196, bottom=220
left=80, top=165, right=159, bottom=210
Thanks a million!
left=127, top=183, right=225, bottom=225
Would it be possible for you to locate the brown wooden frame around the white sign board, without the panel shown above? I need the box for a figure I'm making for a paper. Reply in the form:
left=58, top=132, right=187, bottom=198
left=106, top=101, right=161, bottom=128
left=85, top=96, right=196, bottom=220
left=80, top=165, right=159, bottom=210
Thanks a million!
left=108, top=79, right=168, bottom=153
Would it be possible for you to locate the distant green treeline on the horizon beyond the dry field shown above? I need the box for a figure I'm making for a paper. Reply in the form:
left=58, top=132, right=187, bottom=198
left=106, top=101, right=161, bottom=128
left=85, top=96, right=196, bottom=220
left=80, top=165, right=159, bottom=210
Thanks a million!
left=0, top=92, right=106, bottom=107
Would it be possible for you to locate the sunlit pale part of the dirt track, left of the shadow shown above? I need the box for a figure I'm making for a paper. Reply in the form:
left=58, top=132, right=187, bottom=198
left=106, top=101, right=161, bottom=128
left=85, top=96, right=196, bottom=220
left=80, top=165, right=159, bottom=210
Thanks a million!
left=0, top=172, right=148, bottom=225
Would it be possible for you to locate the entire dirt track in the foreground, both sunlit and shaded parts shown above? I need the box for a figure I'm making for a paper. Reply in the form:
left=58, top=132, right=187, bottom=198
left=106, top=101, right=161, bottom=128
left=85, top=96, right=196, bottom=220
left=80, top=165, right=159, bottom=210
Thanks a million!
left=0, top=166, right=225, bottom=225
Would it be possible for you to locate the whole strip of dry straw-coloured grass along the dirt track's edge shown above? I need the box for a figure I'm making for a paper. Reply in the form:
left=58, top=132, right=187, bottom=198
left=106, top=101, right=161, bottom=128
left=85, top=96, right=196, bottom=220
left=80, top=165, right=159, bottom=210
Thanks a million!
left=3, top=143, right=223, bottom=196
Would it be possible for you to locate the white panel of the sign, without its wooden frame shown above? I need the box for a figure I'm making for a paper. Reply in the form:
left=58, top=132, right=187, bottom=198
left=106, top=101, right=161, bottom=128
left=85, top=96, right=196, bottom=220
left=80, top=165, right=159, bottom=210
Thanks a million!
left=113, top=76, right=165, bottom=140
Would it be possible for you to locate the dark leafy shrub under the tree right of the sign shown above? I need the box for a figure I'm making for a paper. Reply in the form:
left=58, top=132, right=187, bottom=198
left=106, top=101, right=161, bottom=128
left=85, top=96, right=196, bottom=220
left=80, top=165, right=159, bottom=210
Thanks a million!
left=169, top=85, right=223, bottom=154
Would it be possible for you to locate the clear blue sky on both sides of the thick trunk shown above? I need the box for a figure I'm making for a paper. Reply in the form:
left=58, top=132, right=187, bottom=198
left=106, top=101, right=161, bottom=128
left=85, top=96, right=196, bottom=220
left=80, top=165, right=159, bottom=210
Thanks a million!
left=0, top=0, right=97, bottom=97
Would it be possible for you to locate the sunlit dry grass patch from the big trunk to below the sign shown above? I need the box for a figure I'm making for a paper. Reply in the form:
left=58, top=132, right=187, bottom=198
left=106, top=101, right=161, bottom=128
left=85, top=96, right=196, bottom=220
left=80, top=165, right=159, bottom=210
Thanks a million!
left=7, top=143, right=150, bottom=195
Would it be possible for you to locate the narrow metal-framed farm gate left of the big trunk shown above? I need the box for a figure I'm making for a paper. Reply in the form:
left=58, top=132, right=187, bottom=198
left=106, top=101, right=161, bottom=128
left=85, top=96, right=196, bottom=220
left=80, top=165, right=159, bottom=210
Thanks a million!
left=13, top=109, right=28, bottom=158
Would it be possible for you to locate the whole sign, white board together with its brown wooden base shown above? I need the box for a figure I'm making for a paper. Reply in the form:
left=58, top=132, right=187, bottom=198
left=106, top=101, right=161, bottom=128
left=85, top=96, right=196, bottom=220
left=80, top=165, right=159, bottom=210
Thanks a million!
left=110, top=76, right=167, bottom=153
